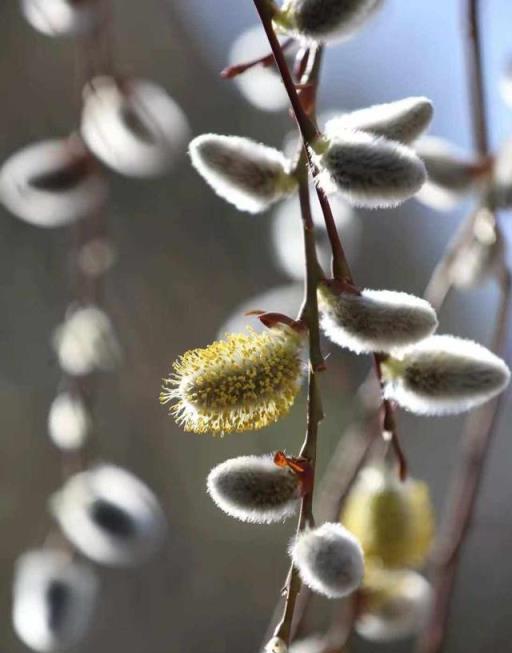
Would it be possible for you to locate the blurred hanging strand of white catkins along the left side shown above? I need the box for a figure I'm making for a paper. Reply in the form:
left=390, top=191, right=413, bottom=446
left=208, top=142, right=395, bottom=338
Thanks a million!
left=0, top=0, right=188, bottom=652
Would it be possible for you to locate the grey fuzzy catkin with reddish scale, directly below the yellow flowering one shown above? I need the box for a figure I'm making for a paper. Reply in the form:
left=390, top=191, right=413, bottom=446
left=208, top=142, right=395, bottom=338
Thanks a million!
left=207, top=455, right=300, bottom=524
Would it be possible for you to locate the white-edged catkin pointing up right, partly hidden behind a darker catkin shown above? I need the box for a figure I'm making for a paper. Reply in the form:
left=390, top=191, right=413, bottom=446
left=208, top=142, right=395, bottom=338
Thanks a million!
left=325, top=97, right=434, bottom=144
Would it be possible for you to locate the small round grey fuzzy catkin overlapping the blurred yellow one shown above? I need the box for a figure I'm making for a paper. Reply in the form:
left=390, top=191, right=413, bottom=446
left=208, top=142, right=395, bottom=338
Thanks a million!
left=289, top=523, right=364, bottom=599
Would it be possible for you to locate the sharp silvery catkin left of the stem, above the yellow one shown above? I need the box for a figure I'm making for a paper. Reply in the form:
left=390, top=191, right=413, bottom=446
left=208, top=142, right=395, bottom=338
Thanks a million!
left=189, top=134, right=296, bottom=213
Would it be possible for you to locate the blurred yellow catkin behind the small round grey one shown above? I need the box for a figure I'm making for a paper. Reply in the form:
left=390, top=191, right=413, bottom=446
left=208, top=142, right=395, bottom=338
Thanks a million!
left=341, top=467, right=434, bottom=568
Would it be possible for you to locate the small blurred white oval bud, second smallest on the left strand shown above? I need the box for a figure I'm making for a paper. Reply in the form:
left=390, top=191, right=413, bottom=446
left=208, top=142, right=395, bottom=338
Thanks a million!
left=48, top=392, right=91, bottom=451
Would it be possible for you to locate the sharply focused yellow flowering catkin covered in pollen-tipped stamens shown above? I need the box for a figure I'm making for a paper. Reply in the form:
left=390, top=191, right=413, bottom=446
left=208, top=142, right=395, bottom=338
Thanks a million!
left=160, top=325, right=304, bottom=435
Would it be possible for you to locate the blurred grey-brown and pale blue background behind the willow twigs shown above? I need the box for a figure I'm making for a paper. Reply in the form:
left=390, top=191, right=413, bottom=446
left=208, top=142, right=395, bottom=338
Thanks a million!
left=0, top=0, right=512, bottom=653
